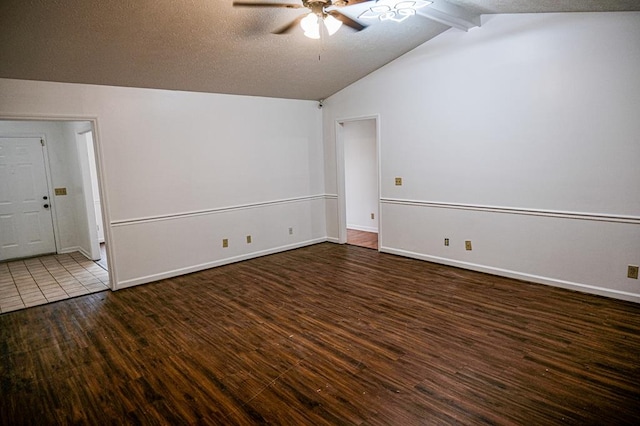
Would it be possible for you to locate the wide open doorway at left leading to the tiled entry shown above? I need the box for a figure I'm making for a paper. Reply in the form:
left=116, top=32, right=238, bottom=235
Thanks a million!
left=0, top=119, right=112, bottom=313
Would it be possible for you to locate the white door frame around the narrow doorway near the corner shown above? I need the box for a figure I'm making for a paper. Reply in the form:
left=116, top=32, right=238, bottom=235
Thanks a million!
left=335, top=114, right=382, bottom=246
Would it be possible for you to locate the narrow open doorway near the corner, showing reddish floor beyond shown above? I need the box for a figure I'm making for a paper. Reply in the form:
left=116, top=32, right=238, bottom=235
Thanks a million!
left=339, top=118, right=380, bottom=250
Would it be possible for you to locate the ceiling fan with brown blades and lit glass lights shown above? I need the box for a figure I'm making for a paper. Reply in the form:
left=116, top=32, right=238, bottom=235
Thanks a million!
left=233, top=0, right=371, bottom=39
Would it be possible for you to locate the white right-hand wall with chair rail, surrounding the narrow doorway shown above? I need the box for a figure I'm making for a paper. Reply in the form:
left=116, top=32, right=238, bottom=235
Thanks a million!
left=323, top=13, right=640, bottom=301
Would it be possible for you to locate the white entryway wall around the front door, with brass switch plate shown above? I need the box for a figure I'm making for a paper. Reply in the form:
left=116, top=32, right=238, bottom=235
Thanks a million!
left=0, top=120, right=87, bottom=253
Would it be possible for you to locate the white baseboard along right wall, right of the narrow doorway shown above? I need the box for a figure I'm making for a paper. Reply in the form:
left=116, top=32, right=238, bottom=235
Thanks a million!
left=380, top=247, right=640, bottom=303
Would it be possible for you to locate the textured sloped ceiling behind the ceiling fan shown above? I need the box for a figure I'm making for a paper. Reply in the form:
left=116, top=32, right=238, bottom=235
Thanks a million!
left=0, top=0, right=640, bottom=99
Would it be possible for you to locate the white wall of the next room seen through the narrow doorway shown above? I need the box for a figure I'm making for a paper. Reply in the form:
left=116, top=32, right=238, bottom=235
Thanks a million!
left=343, top=119, right=379, bottom=232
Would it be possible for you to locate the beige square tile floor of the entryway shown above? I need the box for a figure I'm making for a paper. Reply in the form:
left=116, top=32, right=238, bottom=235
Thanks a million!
left=0, top=252, right=109, bottom=313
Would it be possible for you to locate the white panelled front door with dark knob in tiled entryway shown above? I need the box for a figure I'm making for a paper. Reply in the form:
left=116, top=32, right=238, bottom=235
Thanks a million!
left=0, top=137, right=56, bottom=260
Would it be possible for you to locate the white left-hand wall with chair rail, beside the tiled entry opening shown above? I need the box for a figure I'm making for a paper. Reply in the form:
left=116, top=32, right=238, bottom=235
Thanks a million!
left=0, top=79, right=326, bottom=288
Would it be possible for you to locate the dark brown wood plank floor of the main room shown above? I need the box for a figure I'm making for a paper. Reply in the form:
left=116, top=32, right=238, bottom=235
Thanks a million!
left=0, top=243, right=640, bottom=425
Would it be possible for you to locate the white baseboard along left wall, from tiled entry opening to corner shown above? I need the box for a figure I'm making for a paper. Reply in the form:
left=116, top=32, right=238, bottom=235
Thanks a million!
left=114, top=238, right=328, bottom=290
